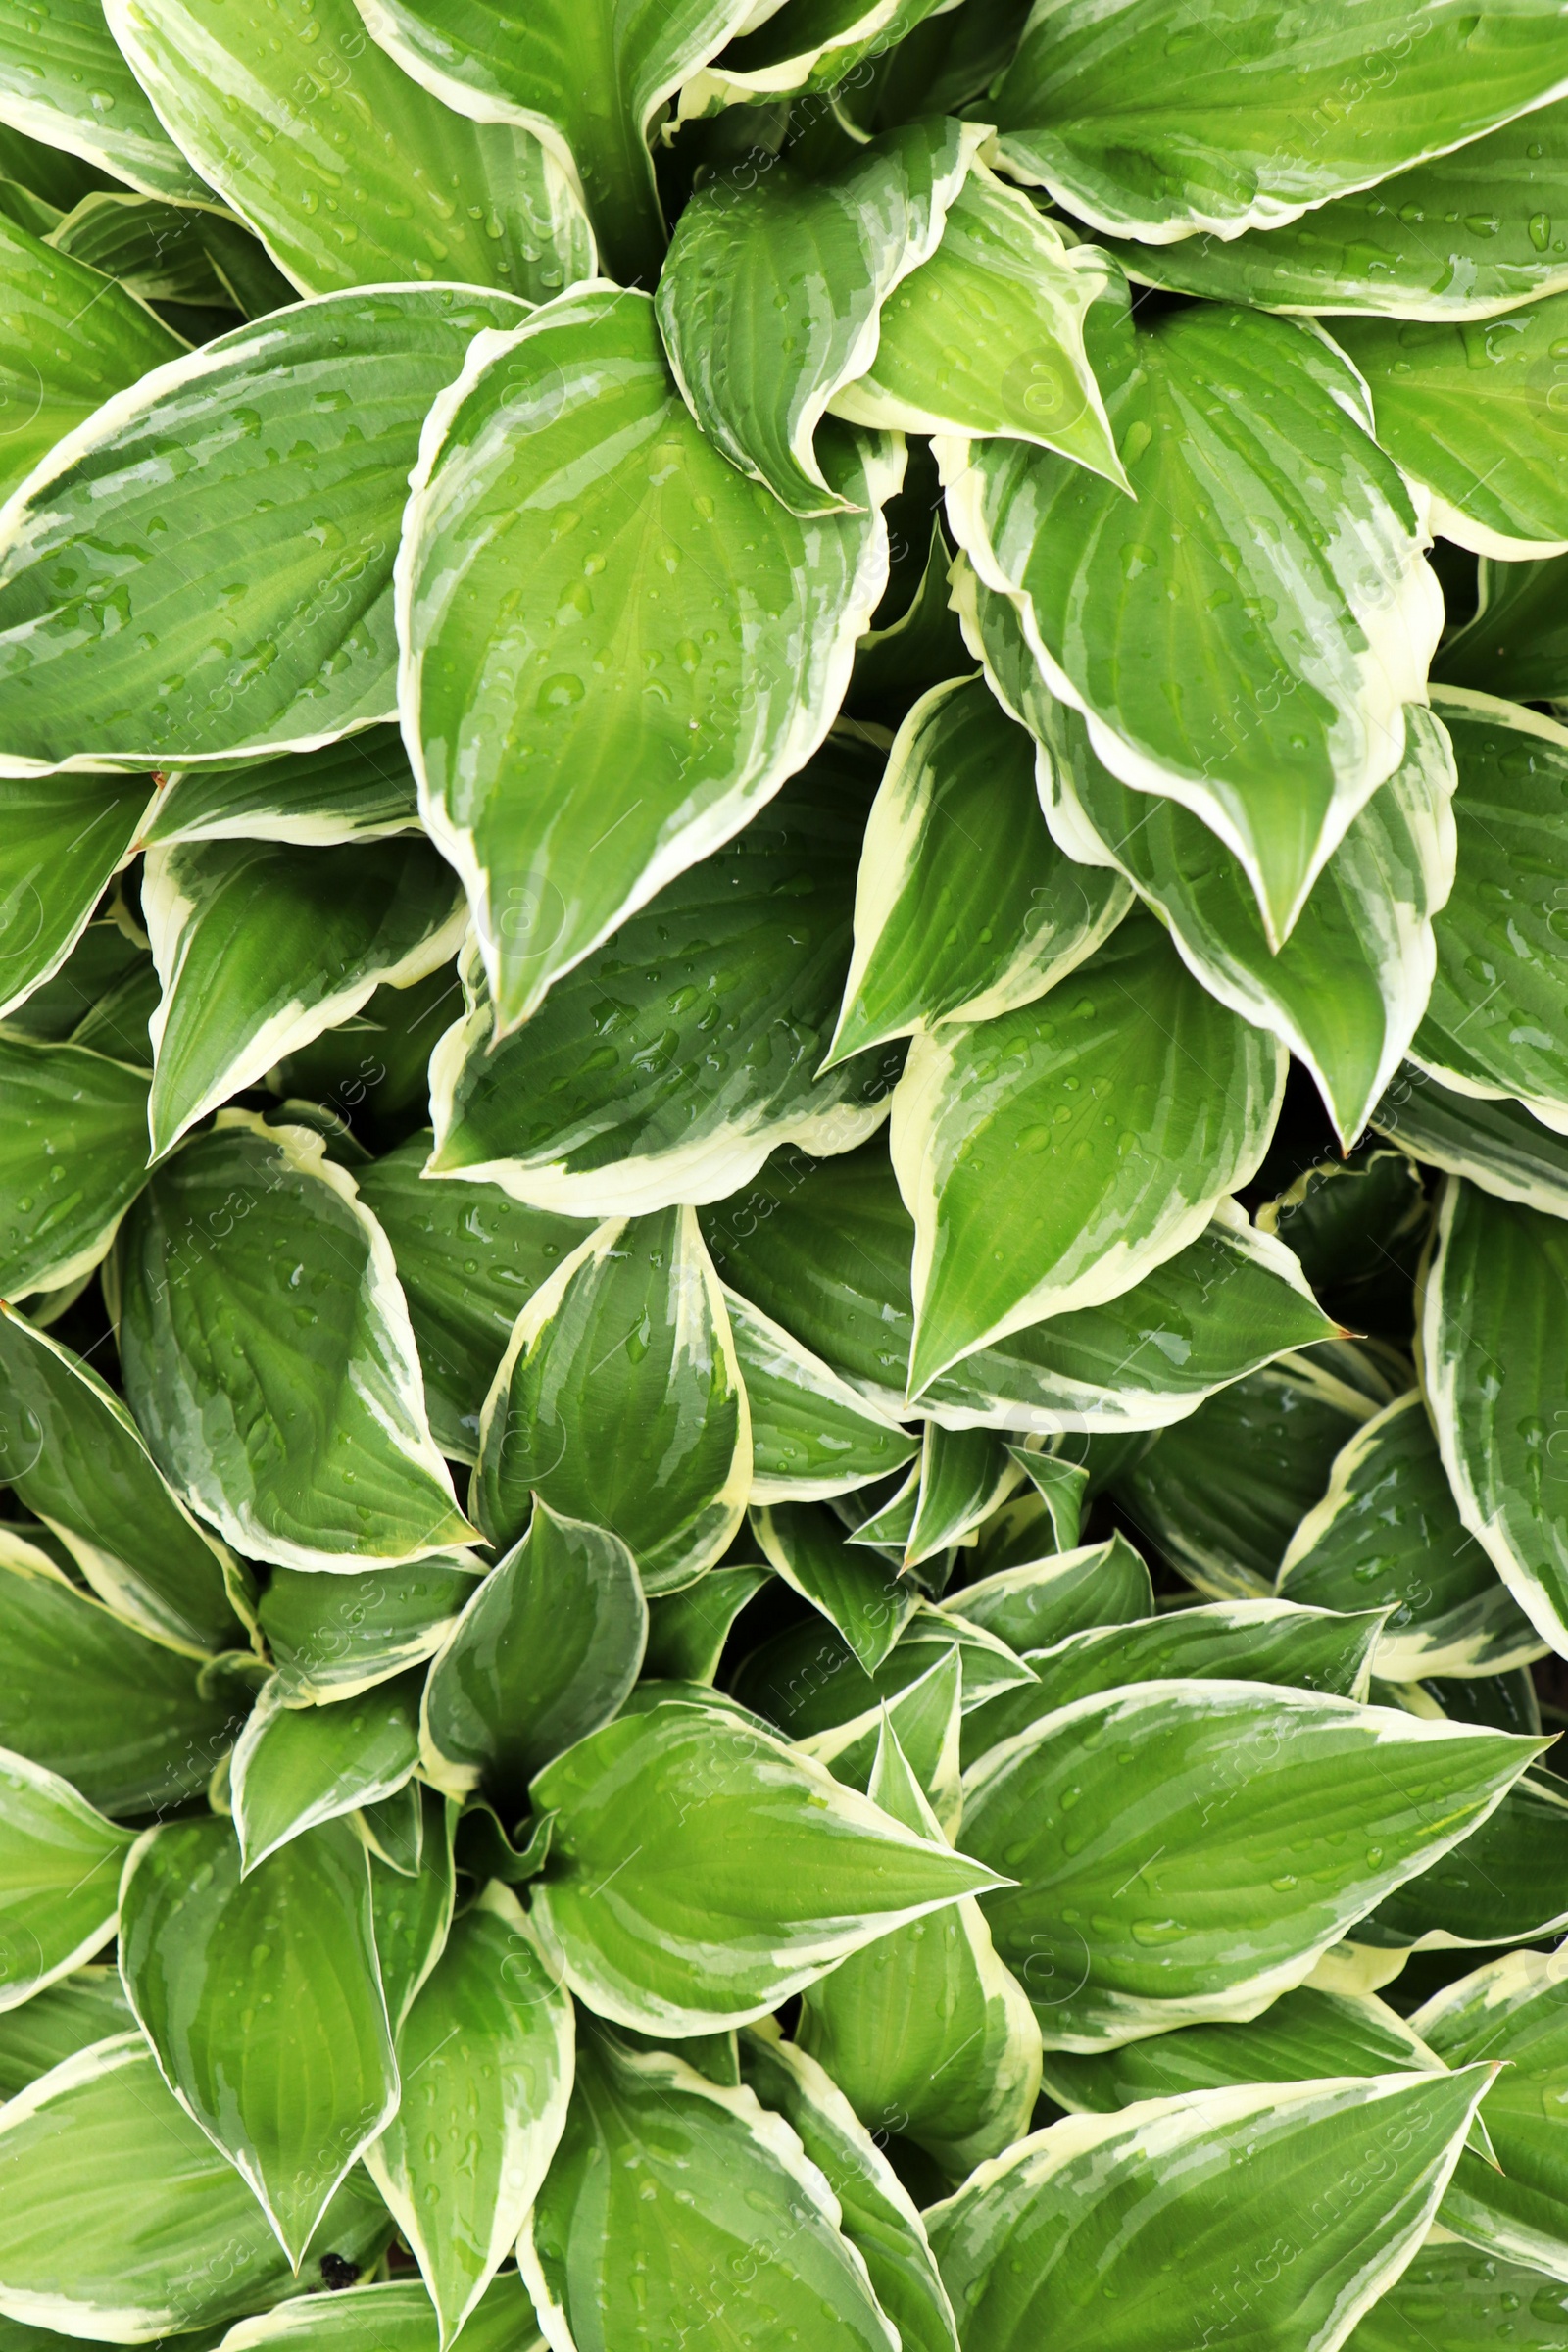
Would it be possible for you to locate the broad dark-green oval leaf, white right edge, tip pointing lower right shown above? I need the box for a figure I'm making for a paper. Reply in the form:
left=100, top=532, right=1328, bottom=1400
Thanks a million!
left=116, top=1110, right=472, bottom=1574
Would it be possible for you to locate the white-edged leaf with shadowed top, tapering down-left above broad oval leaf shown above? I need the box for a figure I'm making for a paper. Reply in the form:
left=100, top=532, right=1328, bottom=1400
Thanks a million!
left=141, top=840, right=467, bottom=1154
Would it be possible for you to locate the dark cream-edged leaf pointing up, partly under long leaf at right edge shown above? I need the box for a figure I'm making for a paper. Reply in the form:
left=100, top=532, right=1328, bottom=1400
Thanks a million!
left=1279, top=1393, right=1543, bottom=1682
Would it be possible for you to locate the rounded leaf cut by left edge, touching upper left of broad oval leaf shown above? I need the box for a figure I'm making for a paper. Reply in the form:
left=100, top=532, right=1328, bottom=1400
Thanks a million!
left=0, top=1037, right=148, bottom=1298
